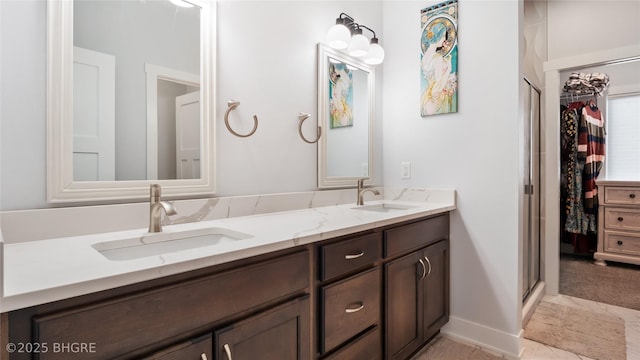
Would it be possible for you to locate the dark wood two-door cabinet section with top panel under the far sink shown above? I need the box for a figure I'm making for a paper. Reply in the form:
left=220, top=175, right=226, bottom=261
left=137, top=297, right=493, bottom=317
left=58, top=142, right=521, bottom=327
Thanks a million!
left=384, top=216, right=449, bottom=360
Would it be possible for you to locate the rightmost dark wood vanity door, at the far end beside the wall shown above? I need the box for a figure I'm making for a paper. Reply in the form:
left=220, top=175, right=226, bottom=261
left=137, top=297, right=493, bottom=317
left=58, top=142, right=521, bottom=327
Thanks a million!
left=422, top=241, right=449, bottom=341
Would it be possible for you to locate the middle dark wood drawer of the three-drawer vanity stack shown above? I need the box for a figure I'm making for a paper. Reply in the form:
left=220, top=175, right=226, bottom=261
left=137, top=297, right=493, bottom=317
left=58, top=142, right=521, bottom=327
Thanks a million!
left=320, top=268, right=381, bottom=353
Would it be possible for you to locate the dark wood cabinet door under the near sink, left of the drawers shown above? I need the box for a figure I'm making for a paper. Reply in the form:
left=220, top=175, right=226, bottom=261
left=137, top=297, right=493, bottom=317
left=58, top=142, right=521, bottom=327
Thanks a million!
left=215, top=296, right=311, bottom=360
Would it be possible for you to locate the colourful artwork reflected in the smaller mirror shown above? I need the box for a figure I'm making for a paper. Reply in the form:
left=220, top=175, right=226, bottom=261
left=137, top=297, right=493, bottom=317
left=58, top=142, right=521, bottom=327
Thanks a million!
left=329, top=62, right=353, bottom=129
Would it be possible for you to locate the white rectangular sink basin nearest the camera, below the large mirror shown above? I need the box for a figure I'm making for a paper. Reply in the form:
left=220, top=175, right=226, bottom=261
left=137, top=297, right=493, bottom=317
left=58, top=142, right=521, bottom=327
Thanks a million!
left=91, top=227, right=253, bottom=260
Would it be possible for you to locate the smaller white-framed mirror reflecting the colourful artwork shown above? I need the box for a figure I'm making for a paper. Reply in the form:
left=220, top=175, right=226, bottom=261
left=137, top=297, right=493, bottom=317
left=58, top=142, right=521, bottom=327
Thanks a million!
left=318, top=44, right=375, bottom=188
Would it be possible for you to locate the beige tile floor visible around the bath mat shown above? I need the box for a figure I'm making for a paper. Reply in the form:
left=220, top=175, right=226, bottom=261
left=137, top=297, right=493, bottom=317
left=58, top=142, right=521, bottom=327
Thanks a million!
left=412, top=295, right=640, bottom=360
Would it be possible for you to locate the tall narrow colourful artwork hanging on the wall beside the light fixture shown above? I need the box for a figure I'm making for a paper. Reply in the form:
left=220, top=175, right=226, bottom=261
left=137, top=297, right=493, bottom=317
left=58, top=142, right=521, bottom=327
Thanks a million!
left=420, top=0, right=458, bottom=116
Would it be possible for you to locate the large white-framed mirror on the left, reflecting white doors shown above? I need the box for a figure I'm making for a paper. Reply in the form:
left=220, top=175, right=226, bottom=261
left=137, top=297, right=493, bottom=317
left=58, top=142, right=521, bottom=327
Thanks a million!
left=47, top=0, right=216, bottom=203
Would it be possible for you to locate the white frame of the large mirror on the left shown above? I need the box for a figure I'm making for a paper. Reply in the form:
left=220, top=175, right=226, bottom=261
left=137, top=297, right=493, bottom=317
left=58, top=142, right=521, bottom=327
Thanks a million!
left=47, top=0, right=216, bottom=203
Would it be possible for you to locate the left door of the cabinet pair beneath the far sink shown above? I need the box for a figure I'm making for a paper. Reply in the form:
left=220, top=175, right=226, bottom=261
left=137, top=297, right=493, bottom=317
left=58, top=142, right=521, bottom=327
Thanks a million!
left=385, top=251, right=426, bottom=359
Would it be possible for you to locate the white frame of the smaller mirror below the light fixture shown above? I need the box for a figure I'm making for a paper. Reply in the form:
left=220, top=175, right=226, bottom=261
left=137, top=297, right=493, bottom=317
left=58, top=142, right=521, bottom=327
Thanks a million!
left=318, top=43, right=376, bottom=189
